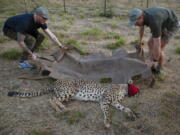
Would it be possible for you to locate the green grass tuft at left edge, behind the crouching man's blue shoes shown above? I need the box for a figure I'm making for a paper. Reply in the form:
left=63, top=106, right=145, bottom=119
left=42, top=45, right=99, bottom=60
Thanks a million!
left=0, top=48, right=22, bottom=60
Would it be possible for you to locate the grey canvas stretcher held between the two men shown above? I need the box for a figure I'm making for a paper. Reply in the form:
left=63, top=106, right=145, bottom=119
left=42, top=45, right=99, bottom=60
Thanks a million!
left=36, top=49, right=152, bottom=83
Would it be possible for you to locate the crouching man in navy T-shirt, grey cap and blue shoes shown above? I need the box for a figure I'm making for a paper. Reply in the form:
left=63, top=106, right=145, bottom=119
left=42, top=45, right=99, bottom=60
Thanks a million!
left=3, top=7, right=62, bottom=69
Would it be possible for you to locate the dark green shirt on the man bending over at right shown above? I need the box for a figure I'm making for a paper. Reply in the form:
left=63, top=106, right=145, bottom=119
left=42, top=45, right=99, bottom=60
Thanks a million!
left=144, top=7, right=178, bottom=38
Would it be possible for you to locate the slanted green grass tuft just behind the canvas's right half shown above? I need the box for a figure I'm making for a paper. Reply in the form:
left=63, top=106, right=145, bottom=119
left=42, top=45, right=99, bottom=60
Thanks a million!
left=106, top=39, right=126, bottom=50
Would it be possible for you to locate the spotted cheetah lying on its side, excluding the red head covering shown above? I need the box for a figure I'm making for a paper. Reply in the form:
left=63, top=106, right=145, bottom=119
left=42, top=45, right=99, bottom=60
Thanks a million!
left=8, top=79, right=139, bottom=128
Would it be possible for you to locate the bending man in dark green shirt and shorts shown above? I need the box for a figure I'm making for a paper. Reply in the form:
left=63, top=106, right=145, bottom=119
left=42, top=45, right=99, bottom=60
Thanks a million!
left=129, top=7, right=178, bottom=73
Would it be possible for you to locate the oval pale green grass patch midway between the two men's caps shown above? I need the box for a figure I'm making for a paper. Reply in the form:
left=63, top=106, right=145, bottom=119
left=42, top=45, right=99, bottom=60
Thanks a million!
left=81, top=28, right=106, bottom=40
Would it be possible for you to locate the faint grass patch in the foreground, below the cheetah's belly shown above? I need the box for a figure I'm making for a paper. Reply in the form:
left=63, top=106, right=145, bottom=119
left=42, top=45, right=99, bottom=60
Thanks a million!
left=57, top=111, right=85, bottom=125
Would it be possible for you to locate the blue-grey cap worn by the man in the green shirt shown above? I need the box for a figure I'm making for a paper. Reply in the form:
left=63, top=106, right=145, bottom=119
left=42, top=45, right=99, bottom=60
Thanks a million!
left=128, top=8, right=143, bottom=26
